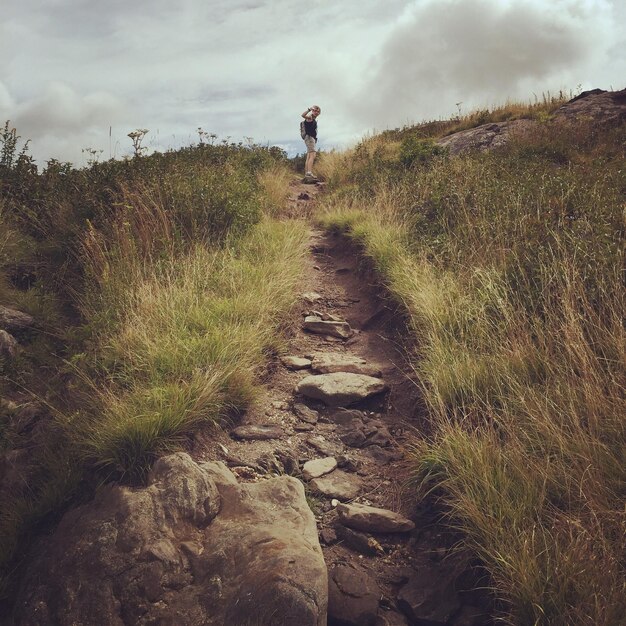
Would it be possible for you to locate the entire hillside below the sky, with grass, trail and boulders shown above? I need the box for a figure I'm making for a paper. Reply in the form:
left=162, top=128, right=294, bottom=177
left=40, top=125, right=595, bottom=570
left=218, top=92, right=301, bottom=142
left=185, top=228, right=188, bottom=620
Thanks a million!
left=0, top=90, right=626, bottom=626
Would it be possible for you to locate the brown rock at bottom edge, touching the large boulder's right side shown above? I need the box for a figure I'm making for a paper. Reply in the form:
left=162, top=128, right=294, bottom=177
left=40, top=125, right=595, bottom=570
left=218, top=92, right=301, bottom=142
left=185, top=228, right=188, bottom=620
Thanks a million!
left=328, top=563, right=381, bottom=626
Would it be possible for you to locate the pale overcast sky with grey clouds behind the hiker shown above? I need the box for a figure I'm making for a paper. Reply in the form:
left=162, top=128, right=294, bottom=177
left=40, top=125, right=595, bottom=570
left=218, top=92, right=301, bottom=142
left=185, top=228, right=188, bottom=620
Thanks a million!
left=0, top=0, right=626, bottom=166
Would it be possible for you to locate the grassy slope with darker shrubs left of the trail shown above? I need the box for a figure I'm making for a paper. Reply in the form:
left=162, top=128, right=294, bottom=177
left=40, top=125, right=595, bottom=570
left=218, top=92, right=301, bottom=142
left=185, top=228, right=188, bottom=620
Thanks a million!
left=0, top=140, right=307, bottom=586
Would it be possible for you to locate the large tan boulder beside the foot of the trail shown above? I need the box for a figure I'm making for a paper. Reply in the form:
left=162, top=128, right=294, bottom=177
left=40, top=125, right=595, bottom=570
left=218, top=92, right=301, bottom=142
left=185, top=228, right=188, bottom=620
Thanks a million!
left=16, top=453, right=327, bottom=626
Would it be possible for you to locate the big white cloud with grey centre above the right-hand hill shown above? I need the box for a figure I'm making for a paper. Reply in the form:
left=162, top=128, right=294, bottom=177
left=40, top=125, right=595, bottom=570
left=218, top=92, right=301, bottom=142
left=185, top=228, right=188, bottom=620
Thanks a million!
left=359, top=0, right=626, bottom=126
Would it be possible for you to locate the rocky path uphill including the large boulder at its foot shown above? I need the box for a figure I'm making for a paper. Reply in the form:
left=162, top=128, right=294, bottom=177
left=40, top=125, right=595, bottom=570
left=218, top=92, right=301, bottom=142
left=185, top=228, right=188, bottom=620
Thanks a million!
left=7, top=178, right=491, bottom=626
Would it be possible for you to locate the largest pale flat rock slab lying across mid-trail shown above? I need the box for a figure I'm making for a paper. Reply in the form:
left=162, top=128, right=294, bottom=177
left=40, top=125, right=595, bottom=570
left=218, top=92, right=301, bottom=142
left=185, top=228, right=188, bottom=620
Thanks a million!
left=296, top=372, right=387, bottom=407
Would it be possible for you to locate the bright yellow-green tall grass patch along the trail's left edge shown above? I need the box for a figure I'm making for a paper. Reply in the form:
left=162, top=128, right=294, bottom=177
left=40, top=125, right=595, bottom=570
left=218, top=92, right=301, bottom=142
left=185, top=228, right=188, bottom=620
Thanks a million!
left=77, top=220, right=305, bottom=474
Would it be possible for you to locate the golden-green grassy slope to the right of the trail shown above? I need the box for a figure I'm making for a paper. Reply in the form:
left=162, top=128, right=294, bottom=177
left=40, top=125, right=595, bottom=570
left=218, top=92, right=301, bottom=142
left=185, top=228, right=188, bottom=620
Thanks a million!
left=318, top=100, right=626, bottom=626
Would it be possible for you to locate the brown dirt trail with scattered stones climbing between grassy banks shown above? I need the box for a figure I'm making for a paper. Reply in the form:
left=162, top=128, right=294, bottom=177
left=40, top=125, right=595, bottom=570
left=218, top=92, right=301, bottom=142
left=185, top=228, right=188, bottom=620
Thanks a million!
left=193, top=184, right=490, bottom=626
